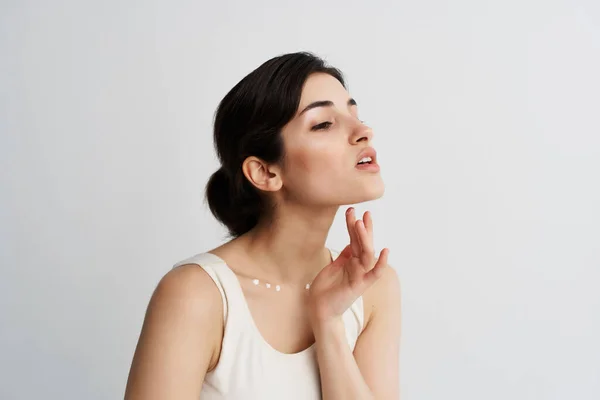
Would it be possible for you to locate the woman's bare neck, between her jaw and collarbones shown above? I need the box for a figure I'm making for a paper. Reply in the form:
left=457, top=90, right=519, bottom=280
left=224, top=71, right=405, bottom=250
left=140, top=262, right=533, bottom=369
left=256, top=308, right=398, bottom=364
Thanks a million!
left=240, top=206, right=338, bottom=286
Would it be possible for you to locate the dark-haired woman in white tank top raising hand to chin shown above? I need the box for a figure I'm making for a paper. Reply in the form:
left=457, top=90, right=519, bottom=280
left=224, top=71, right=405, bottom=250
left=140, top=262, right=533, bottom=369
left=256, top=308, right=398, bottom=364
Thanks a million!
left=125, top=53, right=400, bottom=400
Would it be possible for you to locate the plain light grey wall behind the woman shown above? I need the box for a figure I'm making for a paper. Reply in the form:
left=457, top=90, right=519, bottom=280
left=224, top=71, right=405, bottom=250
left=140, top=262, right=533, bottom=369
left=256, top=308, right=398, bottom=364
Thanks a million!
left=0, top=0, right=600, bottom=400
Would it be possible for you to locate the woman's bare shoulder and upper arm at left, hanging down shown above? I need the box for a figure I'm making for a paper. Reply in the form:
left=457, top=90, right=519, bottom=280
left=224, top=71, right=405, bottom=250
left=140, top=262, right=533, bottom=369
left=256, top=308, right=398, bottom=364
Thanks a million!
left=125, top=264, right=223, bottom=400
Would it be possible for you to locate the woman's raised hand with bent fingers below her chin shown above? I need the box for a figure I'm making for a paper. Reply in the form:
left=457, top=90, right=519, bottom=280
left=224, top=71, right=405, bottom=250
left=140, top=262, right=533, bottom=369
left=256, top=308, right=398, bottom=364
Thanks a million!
left=309, top=207, right=389, bottom=323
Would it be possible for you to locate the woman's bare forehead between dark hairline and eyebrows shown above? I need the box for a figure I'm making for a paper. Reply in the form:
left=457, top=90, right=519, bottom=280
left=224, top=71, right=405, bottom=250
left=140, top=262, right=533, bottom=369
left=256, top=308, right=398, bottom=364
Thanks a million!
left=298, top=72, right=350, bottom=111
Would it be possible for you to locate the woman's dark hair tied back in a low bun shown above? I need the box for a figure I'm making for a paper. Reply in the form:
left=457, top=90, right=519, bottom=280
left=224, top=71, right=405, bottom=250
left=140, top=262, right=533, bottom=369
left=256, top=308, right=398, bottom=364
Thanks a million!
left=206, top=52, right=345, bottom=237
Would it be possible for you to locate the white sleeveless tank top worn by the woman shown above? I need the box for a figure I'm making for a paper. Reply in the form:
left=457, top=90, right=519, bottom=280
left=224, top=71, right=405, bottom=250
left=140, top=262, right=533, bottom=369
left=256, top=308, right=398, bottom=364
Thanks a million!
left=173, top=250, right=364, bottom=400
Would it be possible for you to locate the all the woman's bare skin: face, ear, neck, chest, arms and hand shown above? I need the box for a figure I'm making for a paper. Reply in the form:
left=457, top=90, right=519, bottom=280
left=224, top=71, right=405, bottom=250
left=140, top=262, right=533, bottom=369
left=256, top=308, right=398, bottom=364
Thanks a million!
left=125, top=74, right=401, bottom=400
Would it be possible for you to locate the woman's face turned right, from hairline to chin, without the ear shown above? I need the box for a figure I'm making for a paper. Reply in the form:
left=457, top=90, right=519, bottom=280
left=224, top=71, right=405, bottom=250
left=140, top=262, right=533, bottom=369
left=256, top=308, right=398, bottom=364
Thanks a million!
left=282, top=73, right=384, bottom=206
